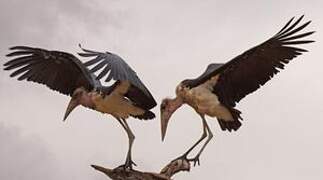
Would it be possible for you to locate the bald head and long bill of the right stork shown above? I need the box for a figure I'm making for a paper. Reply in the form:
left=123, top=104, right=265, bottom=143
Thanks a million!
left=160, top=97, right=183, bottom=140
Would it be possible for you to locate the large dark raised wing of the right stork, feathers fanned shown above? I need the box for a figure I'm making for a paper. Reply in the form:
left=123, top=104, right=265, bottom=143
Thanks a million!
left=186, top=16, right=314, bottom=107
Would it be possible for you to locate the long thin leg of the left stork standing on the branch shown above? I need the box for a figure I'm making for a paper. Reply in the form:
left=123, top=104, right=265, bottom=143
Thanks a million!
left=118, top=119, right=136, bottom=169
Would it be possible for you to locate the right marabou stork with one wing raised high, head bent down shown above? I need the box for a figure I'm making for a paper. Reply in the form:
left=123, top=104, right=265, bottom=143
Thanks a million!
left=160, top=16, right=314, bottom=165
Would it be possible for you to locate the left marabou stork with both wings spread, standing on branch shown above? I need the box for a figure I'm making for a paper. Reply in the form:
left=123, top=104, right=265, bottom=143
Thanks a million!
left=4, top=46, right=157, bottom=169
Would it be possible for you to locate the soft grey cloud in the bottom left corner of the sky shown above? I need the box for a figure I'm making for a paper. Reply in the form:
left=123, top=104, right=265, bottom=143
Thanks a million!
left=0, top=123, right=62, bottom=180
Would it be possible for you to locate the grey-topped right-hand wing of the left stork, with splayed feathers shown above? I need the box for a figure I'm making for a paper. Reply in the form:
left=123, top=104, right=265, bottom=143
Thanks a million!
left=79, top=46, right=157, bottom=109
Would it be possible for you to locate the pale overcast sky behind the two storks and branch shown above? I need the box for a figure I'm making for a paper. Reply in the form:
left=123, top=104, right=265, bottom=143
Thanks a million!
left=0, top=0, right=323, bottom=180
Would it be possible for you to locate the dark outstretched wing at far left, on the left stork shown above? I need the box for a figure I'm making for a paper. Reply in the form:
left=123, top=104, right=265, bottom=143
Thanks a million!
left=4, top=46, right=95, bottom=95
